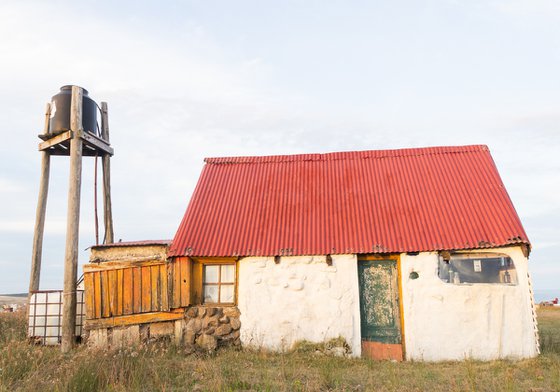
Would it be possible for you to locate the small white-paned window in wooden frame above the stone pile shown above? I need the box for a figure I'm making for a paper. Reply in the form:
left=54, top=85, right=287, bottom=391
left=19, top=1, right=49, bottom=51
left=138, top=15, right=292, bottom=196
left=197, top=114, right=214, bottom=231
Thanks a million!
left=202, top=264, right=235, bottom=304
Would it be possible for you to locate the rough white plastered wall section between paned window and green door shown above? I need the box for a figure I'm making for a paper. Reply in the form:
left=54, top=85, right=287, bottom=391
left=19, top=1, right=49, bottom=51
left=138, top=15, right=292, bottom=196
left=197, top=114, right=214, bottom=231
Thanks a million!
left=238, top=255, right=361, bottom=356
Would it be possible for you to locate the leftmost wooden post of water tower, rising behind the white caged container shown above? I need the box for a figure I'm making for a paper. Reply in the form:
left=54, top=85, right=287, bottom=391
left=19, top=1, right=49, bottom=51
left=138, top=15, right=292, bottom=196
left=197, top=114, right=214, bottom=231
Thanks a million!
left=29, top=103, right=51, bottom=296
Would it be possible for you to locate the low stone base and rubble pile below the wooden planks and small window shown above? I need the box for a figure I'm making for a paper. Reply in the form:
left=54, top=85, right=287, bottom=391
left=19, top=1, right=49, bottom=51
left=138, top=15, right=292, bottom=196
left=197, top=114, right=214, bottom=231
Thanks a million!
left=87, top=306, right=241, bottom=351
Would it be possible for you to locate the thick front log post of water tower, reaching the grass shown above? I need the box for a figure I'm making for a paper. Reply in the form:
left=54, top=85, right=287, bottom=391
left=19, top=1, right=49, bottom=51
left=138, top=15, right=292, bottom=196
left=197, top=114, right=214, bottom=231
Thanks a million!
left=61, top=86, right=83, bottom=353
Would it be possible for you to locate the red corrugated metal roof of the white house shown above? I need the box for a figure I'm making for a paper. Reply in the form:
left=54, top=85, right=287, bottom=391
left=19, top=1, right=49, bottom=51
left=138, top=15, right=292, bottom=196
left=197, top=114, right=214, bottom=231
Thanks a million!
left=170, top=146, right=529, bottom=256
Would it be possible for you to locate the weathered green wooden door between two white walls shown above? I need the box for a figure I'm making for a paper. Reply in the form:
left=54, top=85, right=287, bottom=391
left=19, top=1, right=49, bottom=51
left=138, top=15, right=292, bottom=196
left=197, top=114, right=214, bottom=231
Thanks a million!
left=358, top=259, right=401, bottom=344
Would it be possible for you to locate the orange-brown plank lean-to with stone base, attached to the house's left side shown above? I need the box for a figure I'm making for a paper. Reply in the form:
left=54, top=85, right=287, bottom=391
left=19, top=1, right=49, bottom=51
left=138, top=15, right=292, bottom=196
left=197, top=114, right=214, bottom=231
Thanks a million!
left=84, top=241, right=239, bottom=348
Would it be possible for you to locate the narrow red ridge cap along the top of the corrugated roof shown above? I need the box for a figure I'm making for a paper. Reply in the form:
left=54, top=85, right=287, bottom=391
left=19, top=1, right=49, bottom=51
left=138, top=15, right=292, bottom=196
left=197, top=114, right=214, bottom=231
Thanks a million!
left=204, top=144, right=489, bottom=165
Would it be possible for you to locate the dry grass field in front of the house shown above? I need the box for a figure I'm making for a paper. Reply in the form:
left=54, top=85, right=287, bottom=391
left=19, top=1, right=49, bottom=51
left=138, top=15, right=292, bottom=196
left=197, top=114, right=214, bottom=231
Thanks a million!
left=0, top=308, right=560, bottom=392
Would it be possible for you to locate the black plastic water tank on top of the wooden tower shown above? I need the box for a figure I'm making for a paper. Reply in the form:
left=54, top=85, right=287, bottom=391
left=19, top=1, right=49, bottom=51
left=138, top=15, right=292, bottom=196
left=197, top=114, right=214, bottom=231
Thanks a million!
left=49, top=86, right=97, bottom=134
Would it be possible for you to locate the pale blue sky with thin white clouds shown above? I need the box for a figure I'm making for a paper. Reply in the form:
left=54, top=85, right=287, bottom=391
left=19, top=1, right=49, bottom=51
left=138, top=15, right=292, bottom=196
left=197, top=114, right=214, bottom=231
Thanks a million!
left=0, top=0, right=560, bottom=293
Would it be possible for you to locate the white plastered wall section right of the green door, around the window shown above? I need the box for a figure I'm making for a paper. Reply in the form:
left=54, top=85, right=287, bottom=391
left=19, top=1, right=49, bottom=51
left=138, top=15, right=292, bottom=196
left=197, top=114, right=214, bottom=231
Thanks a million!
left=401, top=247, right=537, bottom=361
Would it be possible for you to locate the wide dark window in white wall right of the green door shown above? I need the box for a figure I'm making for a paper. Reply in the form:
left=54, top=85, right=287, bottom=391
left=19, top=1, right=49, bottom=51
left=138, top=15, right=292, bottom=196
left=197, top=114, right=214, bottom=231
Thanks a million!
left=438, top=253, right=517, bottom=284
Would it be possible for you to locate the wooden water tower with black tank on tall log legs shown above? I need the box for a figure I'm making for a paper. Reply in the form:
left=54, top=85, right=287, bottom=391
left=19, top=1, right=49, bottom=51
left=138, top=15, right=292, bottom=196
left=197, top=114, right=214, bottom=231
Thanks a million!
left=29, top=86, right=113, bottom=352
